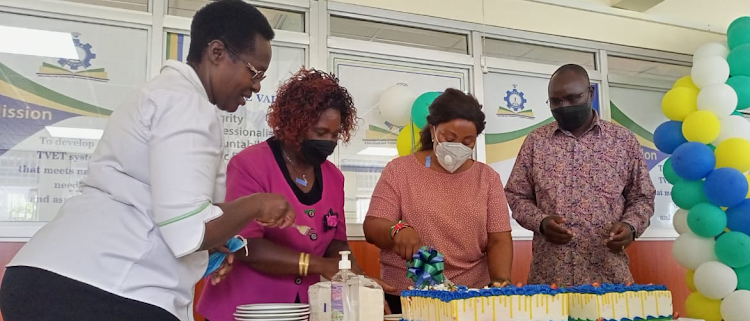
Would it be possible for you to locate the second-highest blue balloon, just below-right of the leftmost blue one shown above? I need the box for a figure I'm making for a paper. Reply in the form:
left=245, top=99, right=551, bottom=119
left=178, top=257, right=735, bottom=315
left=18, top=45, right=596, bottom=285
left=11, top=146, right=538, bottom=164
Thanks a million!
left=672, top=142, right=716, bottom=181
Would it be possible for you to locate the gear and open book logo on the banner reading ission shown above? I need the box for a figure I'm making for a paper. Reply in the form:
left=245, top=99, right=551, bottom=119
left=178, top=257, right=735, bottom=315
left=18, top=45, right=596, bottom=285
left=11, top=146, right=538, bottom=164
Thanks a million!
left=37, top=32, right=109, bottom=81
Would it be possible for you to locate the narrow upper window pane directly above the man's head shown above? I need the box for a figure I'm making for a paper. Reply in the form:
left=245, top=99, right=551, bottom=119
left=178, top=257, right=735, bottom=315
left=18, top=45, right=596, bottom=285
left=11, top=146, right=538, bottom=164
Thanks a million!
left=484, top=38, right=598, bottom=70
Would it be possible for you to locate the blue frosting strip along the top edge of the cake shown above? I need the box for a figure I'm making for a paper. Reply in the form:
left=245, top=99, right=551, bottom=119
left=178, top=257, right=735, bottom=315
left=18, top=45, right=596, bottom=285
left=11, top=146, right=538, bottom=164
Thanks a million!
left=401, top=284, right=667, bottom=302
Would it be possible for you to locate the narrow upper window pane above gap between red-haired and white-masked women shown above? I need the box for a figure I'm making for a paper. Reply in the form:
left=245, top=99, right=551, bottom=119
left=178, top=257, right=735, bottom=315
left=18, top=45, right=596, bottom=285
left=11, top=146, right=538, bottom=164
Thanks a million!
left=330, top=16, right=469, bottom=54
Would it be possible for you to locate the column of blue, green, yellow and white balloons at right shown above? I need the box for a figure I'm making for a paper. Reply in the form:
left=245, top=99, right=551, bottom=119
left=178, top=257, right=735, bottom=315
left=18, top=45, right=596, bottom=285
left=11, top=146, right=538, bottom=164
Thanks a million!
left=654, top=17, right=750, bottom=321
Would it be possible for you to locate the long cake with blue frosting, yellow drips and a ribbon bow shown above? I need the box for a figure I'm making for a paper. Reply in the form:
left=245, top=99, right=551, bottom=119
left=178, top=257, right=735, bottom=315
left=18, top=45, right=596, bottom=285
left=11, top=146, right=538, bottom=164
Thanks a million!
left=401, top=248, right=673, bottom=321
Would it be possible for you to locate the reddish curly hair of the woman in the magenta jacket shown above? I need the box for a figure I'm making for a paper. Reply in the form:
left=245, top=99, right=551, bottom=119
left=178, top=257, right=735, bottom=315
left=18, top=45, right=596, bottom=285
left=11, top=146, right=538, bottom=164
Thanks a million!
left=268, top=67, right=357, bottom=146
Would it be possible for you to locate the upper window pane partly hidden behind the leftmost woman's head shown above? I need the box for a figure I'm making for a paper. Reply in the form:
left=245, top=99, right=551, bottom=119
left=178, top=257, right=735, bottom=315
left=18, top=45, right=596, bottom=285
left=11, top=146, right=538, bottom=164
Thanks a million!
left=166, top=0, right=305, bottom=32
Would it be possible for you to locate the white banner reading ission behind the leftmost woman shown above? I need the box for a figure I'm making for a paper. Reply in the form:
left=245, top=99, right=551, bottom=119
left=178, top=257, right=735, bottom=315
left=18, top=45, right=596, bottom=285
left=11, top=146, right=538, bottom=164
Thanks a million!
left=0, top=13, right=148, bottom=222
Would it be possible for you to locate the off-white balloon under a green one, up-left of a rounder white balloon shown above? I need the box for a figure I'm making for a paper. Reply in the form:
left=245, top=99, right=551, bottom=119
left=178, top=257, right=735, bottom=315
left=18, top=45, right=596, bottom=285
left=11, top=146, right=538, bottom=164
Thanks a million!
left=672, top=231, right=719, bottom=271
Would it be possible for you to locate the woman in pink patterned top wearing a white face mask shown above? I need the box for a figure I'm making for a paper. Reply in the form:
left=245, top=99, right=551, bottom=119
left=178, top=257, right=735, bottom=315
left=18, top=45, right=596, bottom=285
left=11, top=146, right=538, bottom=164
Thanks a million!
left=364, top=89, right=513, bottom=313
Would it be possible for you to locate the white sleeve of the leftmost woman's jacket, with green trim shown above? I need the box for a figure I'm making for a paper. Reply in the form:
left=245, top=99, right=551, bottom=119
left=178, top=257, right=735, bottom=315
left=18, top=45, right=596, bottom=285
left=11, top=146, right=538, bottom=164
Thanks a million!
left=144, top=93, right=222, bottom=258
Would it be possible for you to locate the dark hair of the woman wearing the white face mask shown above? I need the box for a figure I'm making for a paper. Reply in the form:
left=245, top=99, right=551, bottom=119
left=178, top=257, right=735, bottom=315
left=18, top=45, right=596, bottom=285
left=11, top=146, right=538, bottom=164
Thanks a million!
left=420, top=88, right=486, bottom=150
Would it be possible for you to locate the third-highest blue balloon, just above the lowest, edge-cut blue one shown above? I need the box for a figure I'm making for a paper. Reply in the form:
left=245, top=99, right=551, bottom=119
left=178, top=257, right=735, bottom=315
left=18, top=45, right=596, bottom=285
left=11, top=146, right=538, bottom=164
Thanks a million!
left=703, top=167, right=748, bottom=207
